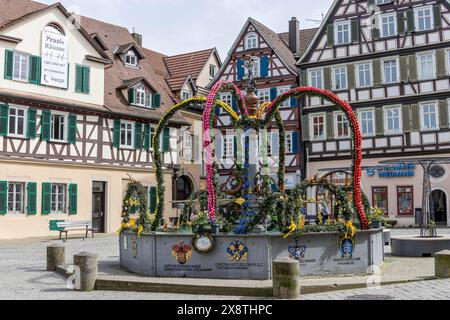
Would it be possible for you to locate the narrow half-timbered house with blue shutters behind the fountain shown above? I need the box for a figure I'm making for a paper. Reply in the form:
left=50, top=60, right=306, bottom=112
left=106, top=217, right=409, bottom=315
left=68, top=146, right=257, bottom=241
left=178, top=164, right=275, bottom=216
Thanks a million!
left=211, top=18, right=317, bottom=189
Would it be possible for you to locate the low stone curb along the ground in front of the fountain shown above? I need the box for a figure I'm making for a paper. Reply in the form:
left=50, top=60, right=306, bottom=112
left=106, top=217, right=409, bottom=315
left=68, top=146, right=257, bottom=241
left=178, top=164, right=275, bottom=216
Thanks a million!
left=52, top=266, right=436, bottom=298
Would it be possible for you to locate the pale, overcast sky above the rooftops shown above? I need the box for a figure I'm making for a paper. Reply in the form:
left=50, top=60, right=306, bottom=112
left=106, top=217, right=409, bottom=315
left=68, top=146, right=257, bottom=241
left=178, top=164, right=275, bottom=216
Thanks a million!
left=36, top=0, right=333, bottom=59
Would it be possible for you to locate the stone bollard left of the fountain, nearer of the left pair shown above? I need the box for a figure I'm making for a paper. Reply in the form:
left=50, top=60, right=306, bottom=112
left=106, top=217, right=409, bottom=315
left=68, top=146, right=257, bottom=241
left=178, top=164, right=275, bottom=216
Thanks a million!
left=73, top=252, right=98, bottom=291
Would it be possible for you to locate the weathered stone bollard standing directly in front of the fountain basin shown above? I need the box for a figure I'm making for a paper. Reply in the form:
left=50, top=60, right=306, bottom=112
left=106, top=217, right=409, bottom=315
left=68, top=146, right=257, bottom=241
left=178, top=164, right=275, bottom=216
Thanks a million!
left=273, top=257, right=300, bottom=299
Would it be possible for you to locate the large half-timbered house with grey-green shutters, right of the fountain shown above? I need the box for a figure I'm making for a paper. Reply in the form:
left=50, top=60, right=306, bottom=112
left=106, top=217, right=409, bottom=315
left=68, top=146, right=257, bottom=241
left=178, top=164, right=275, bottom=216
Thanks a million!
left=297, top=0, right=450, bottom=225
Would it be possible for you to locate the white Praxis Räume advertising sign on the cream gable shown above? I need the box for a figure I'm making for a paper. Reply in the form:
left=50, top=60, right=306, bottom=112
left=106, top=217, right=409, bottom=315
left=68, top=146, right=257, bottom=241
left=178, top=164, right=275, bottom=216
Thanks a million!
left=41, top=30, right=69, bottom=89
